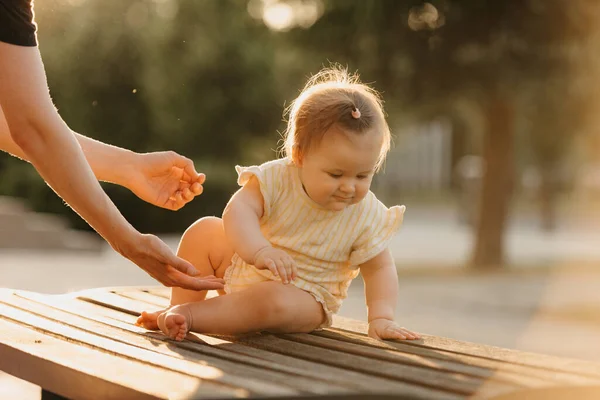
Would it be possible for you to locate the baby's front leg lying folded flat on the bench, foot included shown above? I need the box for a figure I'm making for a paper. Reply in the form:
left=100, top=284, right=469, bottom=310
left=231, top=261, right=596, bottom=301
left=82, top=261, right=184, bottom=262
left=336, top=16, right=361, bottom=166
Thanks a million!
left=158, top=281, right=325, bottom=340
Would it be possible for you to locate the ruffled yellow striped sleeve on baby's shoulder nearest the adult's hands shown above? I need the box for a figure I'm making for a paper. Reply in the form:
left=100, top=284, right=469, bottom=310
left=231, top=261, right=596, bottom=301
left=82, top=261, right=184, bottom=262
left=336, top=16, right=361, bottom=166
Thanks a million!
left=235, top=162, right=282, bottom=218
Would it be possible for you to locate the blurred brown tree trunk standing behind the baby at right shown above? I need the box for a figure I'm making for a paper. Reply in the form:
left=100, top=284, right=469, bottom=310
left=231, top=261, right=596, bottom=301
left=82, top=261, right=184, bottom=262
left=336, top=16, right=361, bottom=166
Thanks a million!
left=471, top=94, right=514, bottom=270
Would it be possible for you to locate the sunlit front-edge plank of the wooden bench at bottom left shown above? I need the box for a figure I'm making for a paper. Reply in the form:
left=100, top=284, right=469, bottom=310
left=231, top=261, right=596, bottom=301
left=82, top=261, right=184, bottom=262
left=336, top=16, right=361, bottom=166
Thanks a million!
left=0, top=318, right=232, bottom=400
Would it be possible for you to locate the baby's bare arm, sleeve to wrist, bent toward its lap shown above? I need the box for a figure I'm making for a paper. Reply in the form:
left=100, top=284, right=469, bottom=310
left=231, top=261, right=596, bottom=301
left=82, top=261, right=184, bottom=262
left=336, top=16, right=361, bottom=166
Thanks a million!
left=223, top=201, right=271, bottom=264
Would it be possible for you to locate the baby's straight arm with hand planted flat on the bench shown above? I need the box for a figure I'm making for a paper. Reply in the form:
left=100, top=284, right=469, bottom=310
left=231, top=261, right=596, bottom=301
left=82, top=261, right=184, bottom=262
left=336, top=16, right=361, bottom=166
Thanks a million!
left=360, top=249, right=420, bottom=339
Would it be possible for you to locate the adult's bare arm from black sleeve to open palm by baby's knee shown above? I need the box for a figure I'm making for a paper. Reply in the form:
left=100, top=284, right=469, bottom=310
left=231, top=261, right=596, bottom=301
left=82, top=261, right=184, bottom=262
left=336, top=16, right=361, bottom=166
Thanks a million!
left=0, top=42, right=222, bottom=290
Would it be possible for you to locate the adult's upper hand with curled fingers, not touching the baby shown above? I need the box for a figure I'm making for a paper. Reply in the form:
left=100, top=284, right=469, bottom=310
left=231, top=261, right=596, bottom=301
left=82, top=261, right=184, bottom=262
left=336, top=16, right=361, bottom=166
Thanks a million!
left=125, top=151, right=206, bottom=211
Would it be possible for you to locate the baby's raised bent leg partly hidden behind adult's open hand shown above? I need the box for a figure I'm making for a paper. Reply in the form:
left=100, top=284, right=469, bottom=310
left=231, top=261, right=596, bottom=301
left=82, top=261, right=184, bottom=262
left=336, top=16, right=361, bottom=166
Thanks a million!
left=136, top=217, right=233, bottom=329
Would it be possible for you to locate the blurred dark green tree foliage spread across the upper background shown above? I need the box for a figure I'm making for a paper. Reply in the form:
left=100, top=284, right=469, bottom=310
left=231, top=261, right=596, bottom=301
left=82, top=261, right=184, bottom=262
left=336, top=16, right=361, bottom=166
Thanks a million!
left=0, top=0, right=599, bottom=239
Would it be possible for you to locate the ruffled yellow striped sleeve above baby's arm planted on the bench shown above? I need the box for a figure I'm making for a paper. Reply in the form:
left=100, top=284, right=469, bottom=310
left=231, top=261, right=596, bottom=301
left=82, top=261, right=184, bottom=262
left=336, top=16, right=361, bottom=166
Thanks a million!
left=350, top=199, right=406, bottom=268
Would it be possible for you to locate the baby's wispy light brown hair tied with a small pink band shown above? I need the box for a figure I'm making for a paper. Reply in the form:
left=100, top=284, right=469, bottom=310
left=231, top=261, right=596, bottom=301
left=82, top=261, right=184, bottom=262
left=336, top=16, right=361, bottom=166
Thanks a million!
left=283, top=65, right=391, bottom=170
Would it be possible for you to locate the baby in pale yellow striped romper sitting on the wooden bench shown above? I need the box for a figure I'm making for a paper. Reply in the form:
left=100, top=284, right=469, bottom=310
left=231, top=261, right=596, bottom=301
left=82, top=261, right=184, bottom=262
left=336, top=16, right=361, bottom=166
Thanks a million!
left=137, top=68, right=419, bottom=340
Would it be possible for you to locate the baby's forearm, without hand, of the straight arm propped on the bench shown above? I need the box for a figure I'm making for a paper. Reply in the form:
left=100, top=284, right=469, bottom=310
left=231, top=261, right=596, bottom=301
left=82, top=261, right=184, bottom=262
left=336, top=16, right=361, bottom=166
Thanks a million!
left=362, top=264, right=398, bottom=321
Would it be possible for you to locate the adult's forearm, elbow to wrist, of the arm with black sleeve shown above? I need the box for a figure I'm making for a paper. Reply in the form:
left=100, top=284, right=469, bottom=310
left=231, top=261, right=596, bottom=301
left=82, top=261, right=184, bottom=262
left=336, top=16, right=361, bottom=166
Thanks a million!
left=11, top=118, right=137, bottom=251
